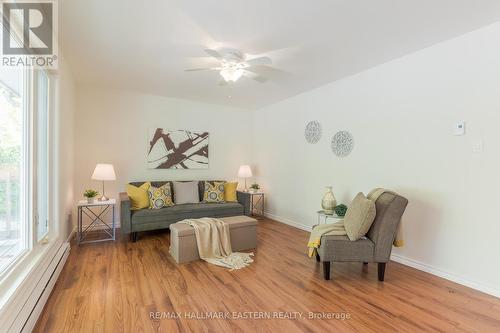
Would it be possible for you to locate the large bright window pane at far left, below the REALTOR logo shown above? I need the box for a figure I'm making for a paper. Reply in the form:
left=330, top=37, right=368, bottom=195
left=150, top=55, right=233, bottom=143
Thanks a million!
left=0, top=67, right=29, bottom=273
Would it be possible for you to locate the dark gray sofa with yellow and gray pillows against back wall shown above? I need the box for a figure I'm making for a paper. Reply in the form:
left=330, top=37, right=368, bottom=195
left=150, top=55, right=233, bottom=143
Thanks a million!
left=120, top=181, right=250, bottom=242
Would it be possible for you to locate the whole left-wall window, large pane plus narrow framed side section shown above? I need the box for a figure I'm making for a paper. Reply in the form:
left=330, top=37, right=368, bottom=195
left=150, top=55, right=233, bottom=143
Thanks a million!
left=0, top=63, right=51, bottom=276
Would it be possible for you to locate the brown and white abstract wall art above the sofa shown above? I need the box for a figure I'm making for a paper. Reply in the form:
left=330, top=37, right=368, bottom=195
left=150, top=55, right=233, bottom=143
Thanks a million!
left=148, top=128, right=208, bottom=169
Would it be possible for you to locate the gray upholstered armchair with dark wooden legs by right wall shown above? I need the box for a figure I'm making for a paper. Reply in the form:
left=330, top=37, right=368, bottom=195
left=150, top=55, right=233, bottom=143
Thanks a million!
left=316, top=192, right=408, bottom=281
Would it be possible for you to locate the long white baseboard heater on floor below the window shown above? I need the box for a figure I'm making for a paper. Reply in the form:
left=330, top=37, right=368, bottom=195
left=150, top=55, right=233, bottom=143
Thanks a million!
left=8, top=243, right=70, bottom=333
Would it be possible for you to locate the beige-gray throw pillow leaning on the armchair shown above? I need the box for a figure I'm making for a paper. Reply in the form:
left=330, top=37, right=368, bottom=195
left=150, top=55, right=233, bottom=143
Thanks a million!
left=344, top=192, right=376, bottom=241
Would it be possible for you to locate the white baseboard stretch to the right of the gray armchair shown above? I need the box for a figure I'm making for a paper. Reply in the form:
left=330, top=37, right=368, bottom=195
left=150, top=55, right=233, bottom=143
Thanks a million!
left=391, top=253, right=500, bottom=298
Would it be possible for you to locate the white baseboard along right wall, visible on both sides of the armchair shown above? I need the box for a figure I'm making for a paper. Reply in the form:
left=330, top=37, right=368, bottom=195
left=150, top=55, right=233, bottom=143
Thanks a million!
left=264, top=212, right=500, bottom=298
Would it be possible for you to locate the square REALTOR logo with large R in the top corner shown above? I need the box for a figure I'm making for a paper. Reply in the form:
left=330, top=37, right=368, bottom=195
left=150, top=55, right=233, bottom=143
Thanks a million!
left=1, top=0, right=57, bottom=69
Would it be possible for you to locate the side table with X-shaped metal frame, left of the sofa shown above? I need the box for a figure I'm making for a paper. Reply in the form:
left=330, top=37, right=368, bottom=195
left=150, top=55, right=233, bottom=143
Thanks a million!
left=76, top=199, right=116, bottom=244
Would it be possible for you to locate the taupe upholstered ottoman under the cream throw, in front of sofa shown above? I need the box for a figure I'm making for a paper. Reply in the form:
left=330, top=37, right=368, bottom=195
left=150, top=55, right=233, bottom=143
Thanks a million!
left=170, top=215, right=257, bottom=264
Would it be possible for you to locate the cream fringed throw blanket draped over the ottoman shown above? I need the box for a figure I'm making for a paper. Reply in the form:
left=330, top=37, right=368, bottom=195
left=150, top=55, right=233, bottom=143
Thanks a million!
left=179, top=217, right=253, bottom=270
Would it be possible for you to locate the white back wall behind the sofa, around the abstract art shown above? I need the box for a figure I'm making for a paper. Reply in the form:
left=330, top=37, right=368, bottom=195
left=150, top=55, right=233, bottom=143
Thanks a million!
left=74, top=85, right=252, bottom=220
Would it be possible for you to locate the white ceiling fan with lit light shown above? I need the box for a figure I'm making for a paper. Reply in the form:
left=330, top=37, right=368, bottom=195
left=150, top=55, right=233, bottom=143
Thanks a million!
left=185, top=48, right=272, bottom=84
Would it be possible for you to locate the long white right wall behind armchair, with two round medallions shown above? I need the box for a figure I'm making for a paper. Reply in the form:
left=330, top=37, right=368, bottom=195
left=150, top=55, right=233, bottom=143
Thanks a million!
left=253, top=24, right=500, bottom=296
